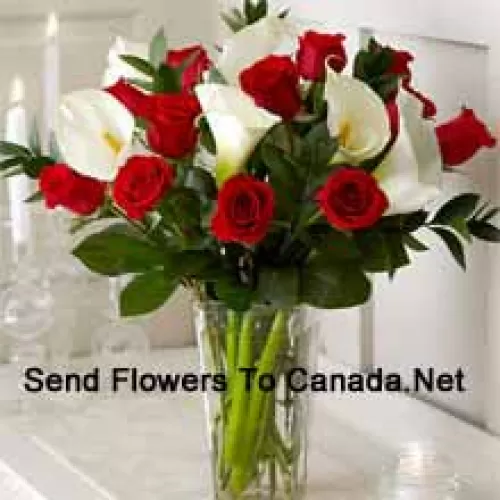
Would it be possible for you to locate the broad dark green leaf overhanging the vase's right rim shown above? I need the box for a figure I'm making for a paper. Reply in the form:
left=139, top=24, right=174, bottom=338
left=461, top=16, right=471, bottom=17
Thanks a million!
left=300, top=260, right=371, bottom=309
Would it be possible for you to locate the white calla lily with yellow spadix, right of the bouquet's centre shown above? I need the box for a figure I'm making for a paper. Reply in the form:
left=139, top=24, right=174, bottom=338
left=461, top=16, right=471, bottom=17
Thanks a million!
left=325, top=67, right=391, bottom=164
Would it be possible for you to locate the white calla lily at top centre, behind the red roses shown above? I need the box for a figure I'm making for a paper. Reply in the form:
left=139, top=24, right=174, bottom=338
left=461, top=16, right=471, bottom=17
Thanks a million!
left=217, top=15, right=291, bottom=85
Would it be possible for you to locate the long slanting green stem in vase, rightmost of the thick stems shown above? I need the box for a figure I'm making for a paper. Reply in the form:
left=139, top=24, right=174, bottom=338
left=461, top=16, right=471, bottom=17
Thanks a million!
left=230, top=311, right=286, bottom=494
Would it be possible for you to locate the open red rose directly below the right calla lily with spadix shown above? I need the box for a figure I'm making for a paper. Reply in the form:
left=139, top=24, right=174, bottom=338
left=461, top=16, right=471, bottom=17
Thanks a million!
left=316, top=167, right=389, bottom=230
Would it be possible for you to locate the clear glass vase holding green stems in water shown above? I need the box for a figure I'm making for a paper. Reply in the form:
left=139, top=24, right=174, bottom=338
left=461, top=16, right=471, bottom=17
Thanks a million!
left=195, top=302, right=316, bottom=500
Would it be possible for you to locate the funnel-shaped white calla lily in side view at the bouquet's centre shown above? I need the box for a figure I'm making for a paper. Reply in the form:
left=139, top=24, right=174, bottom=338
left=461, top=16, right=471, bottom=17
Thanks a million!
left=195, top=83, right=281, bottom=185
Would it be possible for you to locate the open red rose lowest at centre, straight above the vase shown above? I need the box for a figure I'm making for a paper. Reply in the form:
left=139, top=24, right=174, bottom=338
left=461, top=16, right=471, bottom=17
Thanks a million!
left=212, top=174, right=274, bottom=245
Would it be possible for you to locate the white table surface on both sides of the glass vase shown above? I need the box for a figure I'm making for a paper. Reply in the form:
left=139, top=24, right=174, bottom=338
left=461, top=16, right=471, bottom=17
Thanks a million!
left=0, top=349, right=500, bottom=500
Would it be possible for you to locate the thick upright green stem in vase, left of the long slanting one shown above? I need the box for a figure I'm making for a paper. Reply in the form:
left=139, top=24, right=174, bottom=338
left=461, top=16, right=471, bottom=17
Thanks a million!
left=224, top=312, right=253, bottom=466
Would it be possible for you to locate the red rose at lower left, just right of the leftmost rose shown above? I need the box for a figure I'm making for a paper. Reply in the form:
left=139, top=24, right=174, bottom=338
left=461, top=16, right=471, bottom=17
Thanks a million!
left=113, top=155, right=175, bottom=220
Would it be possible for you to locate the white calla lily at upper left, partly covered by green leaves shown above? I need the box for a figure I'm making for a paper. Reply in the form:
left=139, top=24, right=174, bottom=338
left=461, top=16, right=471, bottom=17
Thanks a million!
left=102, top=37, right=149, bottom=87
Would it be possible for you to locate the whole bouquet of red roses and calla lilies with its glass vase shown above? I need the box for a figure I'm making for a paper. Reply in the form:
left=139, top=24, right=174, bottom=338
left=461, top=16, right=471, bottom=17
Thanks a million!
left=0, top=0, right=500, bottom=500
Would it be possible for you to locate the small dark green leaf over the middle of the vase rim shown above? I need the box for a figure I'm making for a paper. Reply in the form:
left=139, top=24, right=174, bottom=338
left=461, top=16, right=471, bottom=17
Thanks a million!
left=256, top=268, right=299, bottom=307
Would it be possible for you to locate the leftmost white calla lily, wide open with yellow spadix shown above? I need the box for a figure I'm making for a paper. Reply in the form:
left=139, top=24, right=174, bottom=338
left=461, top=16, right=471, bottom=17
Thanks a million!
left=54, top=90, right=135, bottom=181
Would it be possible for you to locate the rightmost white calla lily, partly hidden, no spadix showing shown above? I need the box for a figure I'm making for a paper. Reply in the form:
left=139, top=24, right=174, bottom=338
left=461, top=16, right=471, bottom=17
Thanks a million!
left=374, top=91, right=443, bottom=215
